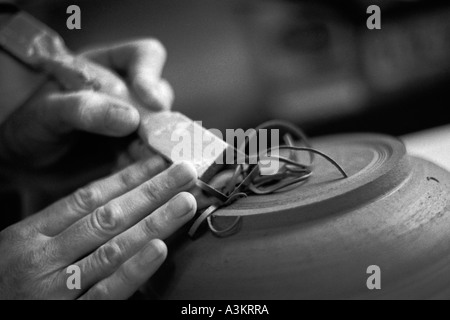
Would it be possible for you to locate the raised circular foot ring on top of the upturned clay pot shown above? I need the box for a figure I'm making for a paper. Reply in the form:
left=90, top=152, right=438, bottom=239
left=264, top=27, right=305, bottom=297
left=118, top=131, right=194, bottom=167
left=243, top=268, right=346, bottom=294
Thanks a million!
left=217, top=134, right=411, bottom=220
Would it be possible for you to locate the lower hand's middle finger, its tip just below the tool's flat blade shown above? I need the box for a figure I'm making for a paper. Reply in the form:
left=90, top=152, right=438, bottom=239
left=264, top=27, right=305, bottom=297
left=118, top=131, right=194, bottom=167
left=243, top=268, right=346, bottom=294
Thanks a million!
left=53, top=163, right=197, bottom=263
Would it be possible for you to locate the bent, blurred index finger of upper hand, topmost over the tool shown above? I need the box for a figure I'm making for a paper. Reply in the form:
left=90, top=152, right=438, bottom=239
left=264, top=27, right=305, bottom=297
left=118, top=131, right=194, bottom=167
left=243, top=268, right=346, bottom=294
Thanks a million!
left=81, top=39, right=174, bottom=111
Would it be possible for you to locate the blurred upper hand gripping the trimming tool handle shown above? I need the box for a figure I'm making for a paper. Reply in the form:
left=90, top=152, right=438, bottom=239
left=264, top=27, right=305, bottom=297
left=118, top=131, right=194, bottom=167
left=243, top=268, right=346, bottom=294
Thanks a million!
left=0, top=40, right=173, bottom=166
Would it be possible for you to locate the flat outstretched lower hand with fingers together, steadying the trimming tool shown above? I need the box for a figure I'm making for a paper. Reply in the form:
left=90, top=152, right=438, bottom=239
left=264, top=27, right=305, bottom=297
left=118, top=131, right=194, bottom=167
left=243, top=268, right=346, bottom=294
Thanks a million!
left=0, top=157, right=196, bottom=299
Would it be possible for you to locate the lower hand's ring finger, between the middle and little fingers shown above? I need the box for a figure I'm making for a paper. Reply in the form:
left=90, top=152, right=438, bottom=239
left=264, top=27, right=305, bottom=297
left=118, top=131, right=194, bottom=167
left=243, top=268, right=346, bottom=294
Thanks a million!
left=73, top=192, right=197, bottom=288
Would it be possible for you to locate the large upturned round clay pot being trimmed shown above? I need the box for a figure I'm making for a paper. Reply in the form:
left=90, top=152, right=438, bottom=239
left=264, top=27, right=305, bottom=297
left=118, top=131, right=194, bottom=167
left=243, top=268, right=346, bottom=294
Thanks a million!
left=149, top=135, right=450, bottom=299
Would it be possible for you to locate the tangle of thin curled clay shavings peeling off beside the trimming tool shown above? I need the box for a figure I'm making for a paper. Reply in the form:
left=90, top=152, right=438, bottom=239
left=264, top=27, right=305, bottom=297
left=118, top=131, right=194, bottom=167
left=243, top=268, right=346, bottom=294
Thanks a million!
left=189, top=120, right=348, bottom=237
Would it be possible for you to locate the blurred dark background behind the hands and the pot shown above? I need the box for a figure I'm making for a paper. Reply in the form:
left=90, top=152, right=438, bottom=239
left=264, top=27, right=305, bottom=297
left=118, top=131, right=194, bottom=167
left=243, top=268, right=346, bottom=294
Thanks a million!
left=22, top=0, right=450, bottom=136
